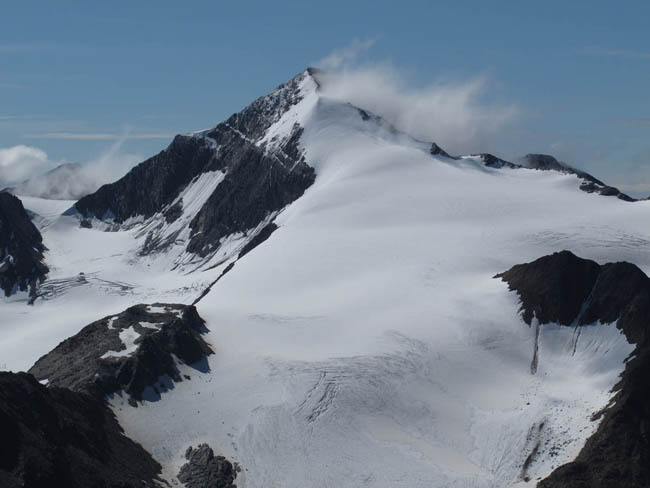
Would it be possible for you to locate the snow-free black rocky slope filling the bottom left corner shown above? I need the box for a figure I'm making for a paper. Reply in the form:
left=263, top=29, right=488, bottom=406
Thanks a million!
left=0, top=372, right=161, bottom=488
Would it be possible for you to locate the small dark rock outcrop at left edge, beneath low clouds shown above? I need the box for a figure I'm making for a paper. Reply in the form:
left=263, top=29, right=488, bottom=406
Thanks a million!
left=0, top=192, right=49, bottom=296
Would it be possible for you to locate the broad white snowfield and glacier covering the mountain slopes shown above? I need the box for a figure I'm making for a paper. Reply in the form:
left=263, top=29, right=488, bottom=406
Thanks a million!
left=0, top=70, right=650, bottom=488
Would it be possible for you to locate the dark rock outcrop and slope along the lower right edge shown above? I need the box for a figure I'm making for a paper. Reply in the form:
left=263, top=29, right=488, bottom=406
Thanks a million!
left=497, top=251, right=650, bottom=488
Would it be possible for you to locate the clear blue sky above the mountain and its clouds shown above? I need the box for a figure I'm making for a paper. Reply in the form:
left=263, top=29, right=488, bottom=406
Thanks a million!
left=0, top=0, right=650, bottom=195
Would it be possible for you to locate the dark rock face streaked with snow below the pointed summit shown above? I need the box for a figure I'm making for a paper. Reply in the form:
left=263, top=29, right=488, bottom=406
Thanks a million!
left=75, top=70, right=315, bottom=256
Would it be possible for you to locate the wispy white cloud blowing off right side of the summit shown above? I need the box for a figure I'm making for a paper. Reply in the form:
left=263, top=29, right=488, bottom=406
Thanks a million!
left=312, top=53, right=521, bottom=154
